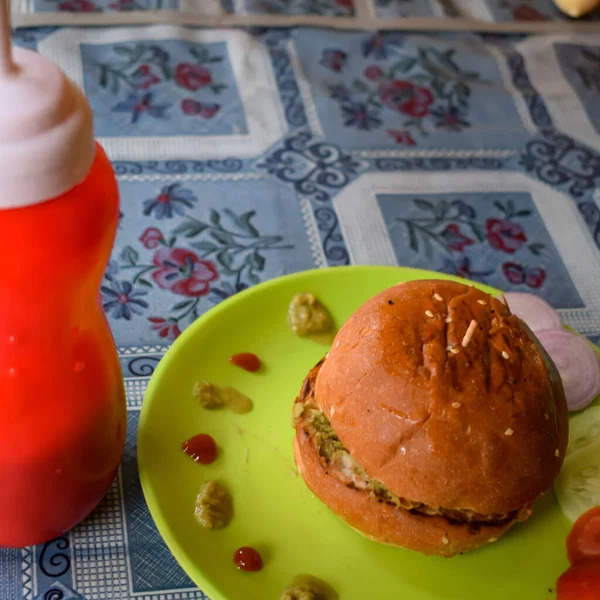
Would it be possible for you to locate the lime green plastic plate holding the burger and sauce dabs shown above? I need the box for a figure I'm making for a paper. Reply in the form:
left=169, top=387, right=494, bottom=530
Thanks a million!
left=138, top=266, right=570, bottom=600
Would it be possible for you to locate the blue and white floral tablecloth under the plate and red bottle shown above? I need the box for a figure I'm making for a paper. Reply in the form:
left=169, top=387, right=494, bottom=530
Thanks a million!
left=0, top=0, right=600, bottom=600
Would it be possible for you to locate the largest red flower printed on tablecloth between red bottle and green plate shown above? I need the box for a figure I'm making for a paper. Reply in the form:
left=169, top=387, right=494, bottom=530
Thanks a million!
left=152, top=248, right=219, bottom=297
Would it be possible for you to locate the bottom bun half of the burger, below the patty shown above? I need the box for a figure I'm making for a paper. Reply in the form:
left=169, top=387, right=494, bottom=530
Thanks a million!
left=294, top=427, right=515, bottom=557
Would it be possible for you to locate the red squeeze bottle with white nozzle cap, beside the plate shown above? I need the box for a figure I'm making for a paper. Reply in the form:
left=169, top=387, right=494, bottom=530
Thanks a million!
left=0, top=0, right=127, bottom=547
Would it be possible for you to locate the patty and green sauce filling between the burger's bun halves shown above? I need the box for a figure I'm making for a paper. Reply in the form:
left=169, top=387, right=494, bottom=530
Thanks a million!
left=293, top=400, right=531, bottom=526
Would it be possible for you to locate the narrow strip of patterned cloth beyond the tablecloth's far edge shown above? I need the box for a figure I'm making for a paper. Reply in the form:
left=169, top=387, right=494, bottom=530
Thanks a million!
left=7, top=0, right=600, bottom=31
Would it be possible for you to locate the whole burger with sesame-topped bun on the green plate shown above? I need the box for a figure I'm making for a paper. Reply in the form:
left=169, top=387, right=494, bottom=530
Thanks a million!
left=293, top=280, right=568, bottom=557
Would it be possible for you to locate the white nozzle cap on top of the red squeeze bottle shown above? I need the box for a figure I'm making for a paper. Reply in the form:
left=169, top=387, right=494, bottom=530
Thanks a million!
left=0, top=0, right=95, bottom=209
